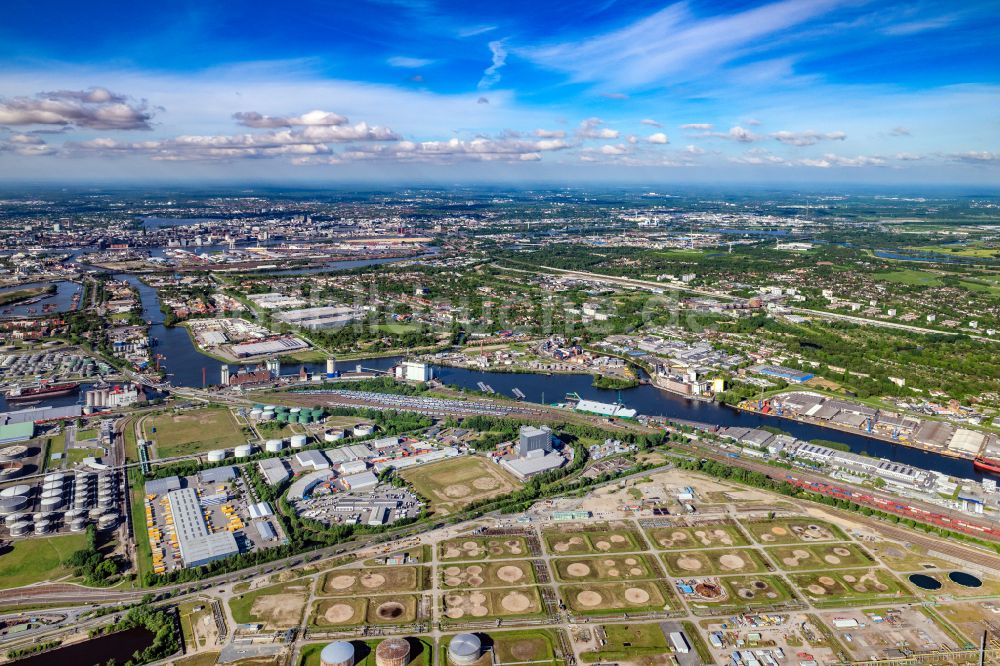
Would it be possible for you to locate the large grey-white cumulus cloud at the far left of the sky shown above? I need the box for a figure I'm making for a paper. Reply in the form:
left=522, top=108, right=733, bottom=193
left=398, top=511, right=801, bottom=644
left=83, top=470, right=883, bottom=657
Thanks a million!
left=0, top=88, right=153, bottom=130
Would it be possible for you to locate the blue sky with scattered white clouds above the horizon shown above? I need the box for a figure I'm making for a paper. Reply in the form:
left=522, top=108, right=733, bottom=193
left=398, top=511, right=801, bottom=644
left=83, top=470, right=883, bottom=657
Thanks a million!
left=0, top=0, right=1000, bottom=185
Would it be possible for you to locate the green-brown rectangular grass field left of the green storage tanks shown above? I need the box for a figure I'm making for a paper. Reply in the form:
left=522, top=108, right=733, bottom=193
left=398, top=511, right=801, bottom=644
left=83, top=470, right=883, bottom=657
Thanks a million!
left=144, top=407, right=246, bottom=458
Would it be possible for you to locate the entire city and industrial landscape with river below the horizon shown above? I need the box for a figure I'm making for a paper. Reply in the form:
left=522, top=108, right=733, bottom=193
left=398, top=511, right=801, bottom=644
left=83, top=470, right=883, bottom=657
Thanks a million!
left=0, top=188, right=1000, bottom=666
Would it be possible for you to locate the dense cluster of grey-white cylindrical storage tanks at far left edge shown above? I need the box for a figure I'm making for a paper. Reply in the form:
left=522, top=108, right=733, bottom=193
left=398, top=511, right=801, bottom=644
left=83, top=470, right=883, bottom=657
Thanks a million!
left=0, top=470, right=119, bottom=537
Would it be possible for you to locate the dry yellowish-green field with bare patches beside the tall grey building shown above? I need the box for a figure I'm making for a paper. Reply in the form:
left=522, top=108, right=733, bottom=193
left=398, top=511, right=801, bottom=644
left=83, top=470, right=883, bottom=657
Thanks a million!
left=400, top=456, right=521, bottom=515
